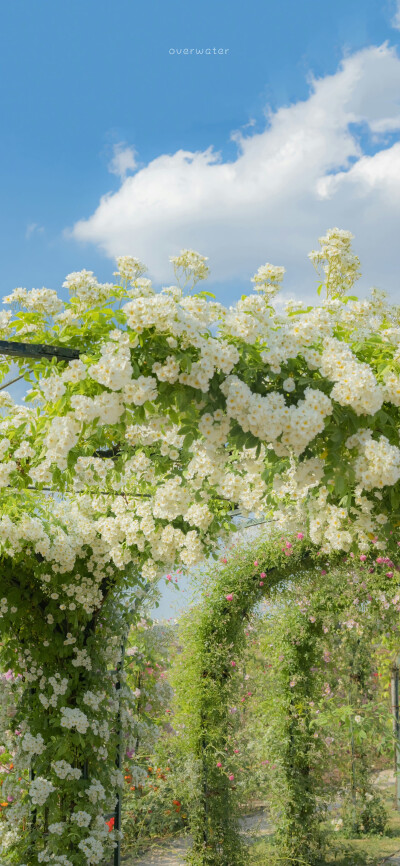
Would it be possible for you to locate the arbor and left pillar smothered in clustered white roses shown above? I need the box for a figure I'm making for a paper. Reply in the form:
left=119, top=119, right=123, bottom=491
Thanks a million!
left=0, top=229, right=400, bottom=866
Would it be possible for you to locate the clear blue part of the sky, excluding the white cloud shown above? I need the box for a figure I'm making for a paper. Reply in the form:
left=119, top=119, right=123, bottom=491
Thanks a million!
left=0, top=0, right=400, bottom=312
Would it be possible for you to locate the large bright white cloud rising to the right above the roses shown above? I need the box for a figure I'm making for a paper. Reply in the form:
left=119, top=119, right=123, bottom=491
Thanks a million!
left=71, top=44, right=400, bottom=293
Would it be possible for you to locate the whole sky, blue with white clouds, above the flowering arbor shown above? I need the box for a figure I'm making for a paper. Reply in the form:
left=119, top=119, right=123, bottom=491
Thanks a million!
left=0, top=0, right=400, bottom=616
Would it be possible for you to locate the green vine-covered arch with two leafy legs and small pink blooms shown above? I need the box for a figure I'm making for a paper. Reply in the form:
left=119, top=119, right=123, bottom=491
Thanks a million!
left=175, top=533, right=400, bottom=866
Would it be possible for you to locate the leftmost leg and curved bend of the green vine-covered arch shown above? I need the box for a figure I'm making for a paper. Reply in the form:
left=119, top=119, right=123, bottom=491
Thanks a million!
left=172, top=533, right=317, bottom=866
